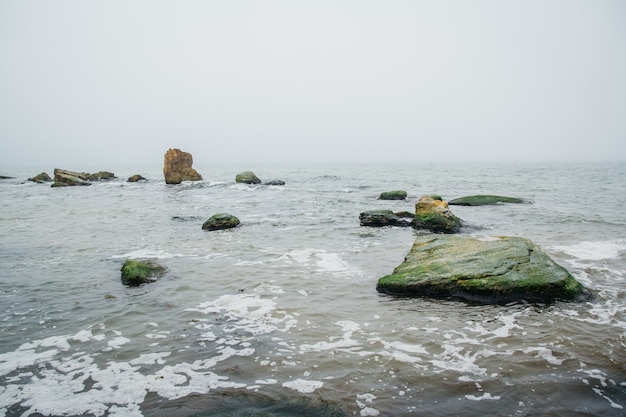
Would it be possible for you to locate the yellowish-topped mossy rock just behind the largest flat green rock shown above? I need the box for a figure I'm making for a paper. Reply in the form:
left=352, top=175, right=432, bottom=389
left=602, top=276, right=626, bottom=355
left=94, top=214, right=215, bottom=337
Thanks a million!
left=414, top=195, right=462, bottom=233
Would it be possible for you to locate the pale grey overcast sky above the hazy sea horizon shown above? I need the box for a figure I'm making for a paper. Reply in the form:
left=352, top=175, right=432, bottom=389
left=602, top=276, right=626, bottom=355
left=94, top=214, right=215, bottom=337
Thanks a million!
left=0, top=0, right=626, bottom=170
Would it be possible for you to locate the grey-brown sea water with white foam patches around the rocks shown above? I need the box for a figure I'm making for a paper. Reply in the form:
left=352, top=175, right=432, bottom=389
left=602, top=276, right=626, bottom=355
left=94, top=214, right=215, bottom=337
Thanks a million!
left=0, top=163, right=626, bottom=417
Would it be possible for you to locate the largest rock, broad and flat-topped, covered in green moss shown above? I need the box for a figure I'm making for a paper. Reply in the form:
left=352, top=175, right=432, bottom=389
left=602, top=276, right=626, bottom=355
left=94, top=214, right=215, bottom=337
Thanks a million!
left=376, top=235, right=589, bottom=304
